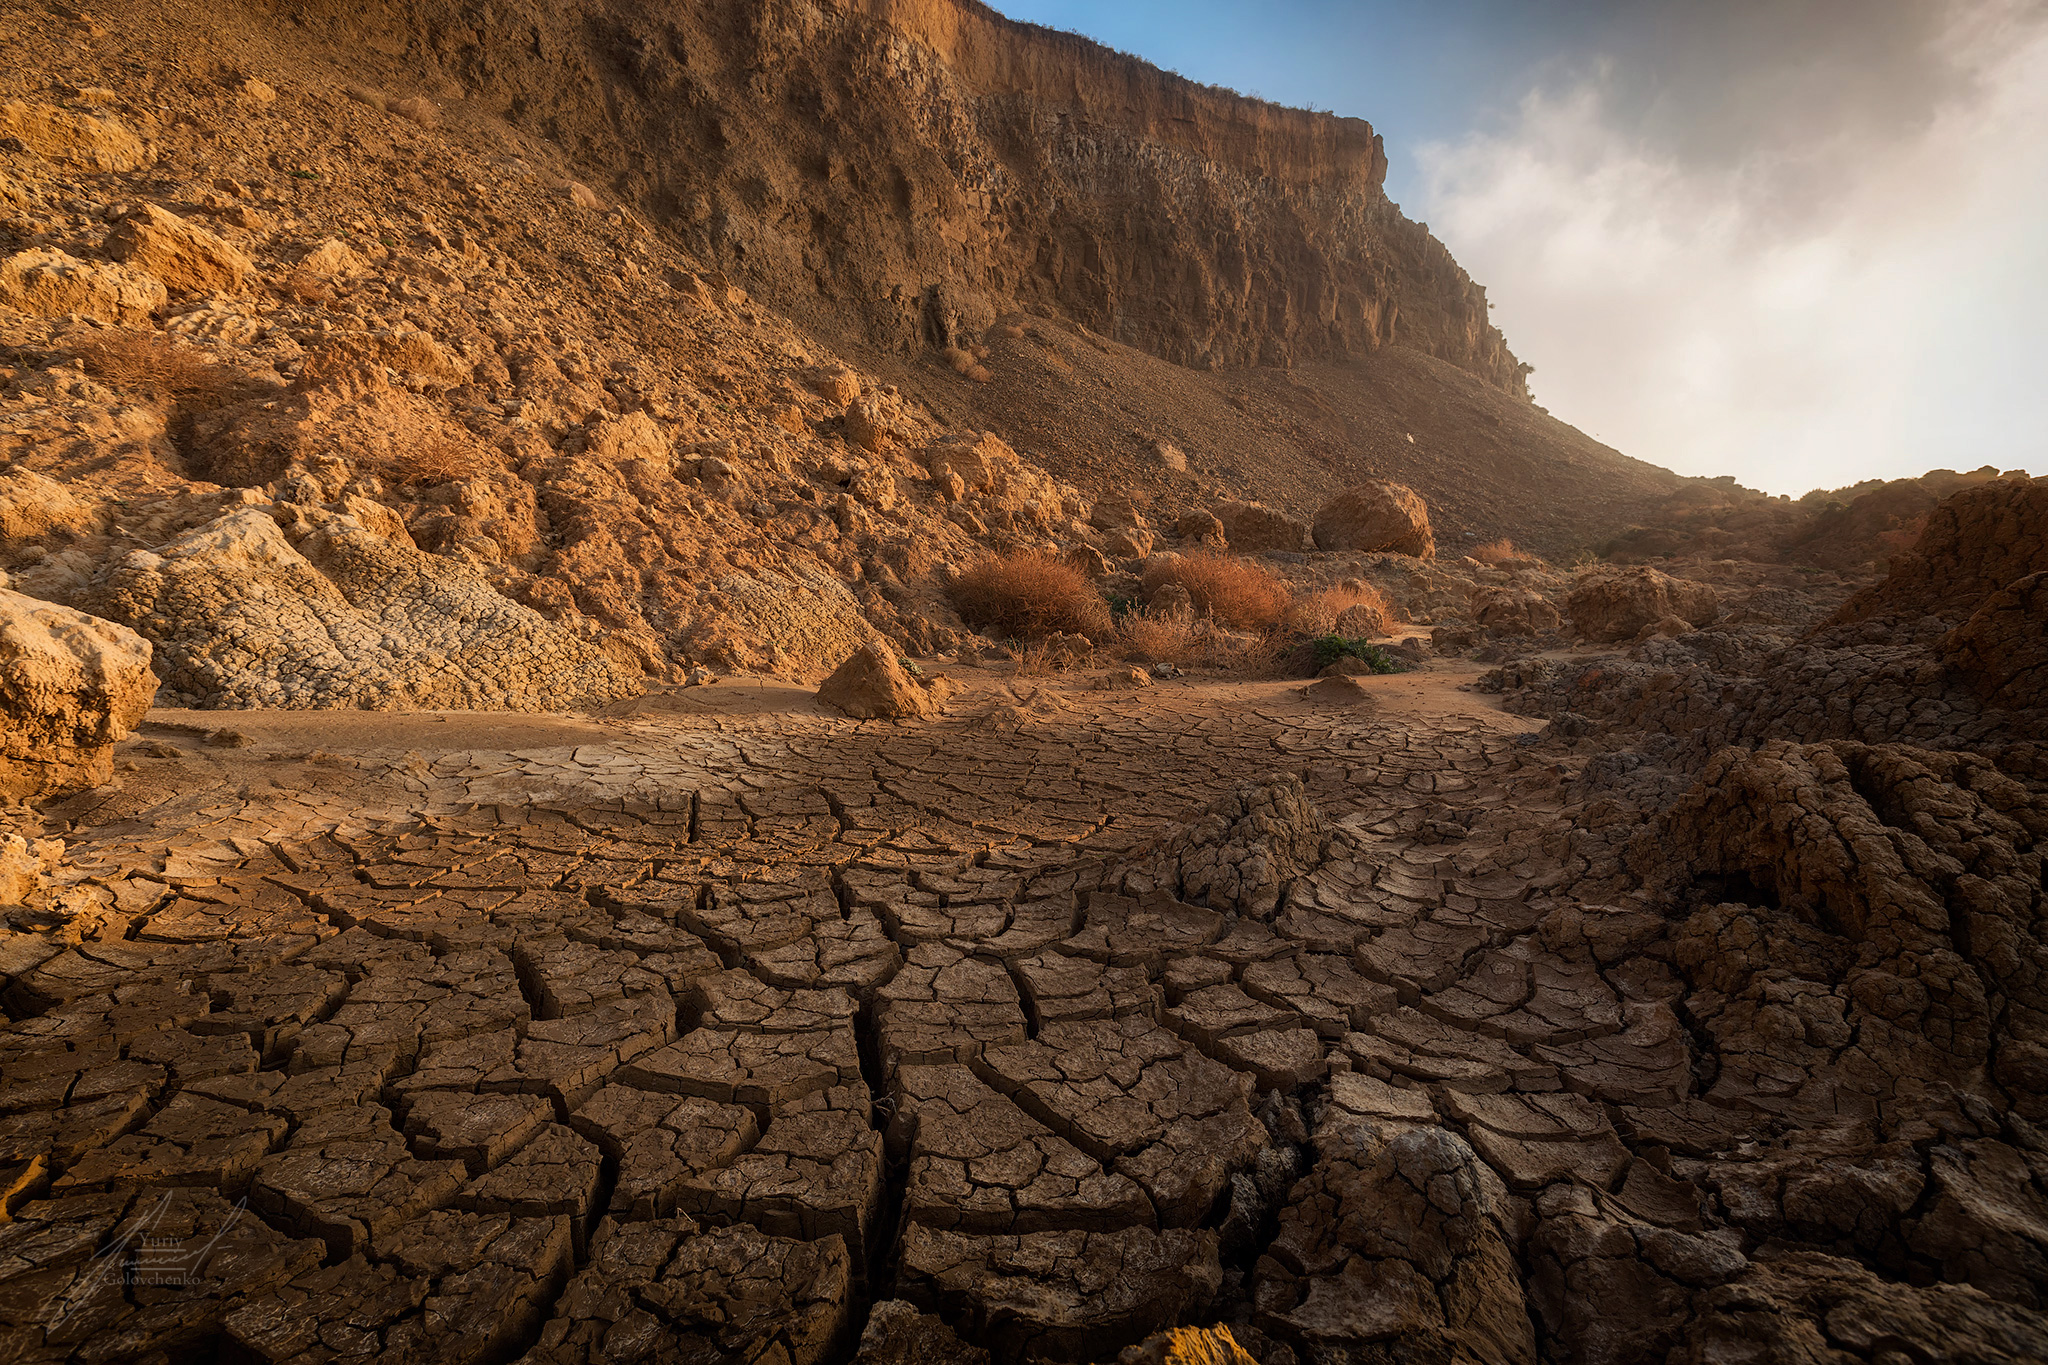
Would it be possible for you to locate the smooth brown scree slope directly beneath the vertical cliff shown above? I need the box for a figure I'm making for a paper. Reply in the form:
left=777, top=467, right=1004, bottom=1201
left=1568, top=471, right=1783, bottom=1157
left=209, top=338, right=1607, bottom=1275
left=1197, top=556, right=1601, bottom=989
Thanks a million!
left=888, top=331, right=1696, bottom=559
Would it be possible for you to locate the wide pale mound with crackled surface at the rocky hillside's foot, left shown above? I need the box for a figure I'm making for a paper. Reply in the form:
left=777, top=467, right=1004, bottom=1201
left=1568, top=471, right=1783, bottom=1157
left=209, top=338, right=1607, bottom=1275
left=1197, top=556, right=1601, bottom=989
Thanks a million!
left=94, top=508, right=643, bottom=710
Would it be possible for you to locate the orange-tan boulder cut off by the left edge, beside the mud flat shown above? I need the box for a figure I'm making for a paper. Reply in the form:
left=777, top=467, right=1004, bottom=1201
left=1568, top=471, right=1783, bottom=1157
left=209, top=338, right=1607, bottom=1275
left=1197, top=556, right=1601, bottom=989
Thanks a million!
left=0, top=587, right=156, bottom=800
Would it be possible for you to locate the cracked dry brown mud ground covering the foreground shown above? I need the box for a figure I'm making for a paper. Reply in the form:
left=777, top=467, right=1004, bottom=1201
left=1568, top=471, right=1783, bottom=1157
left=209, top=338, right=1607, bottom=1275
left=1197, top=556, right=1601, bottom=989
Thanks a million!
left=0, top=679, right=2048, bottom=1365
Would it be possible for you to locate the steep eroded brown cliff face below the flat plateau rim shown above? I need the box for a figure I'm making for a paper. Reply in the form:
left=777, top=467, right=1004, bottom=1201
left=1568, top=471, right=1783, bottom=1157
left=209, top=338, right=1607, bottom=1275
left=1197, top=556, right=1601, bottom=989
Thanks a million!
left=258, top=0, right=1526, bottom=393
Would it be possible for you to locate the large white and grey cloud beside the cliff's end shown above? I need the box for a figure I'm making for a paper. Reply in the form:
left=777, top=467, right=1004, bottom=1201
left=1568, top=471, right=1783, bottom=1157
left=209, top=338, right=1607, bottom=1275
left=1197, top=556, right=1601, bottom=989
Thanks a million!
left=1419, top=0, right=2048, bottom=493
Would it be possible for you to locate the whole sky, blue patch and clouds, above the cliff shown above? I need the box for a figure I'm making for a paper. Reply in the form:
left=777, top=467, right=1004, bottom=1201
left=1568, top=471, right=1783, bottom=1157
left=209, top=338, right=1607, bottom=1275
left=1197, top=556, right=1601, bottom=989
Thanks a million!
left=993, top=0, right=2048, bottom=495
